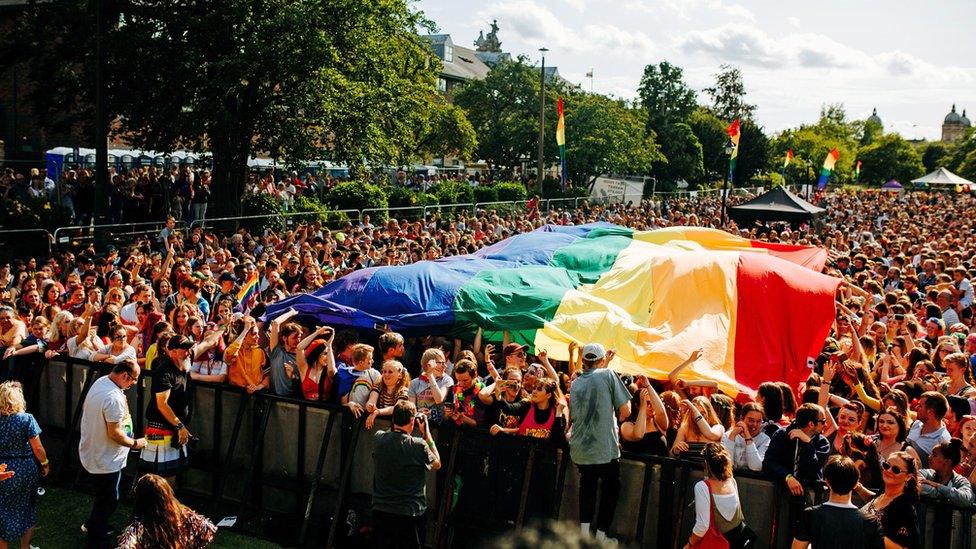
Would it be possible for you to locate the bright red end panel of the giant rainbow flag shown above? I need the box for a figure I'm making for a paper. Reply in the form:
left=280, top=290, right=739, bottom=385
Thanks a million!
left=735, top=253, right=840, bottom=389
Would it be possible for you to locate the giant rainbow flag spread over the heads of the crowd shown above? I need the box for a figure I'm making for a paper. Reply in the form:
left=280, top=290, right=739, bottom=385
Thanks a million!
left=266, top=223, right=838, bottom=392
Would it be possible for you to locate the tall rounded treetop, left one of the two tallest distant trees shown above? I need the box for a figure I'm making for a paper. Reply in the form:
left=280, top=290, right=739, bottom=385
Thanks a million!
left=637, top=61, right=696, bottom=133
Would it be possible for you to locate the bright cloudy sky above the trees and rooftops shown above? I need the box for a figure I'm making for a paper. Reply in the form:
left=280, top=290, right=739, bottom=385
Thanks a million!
left=415, top=0, right=976, bottom=139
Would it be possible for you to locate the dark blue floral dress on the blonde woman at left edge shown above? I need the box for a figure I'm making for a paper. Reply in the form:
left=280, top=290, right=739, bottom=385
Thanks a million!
left=0, top=413, right=41, bottom=541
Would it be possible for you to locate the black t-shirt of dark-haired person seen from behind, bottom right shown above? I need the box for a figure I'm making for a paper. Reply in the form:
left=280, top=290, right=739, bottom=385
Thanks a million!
left=796, top=504, right=884, bottom=549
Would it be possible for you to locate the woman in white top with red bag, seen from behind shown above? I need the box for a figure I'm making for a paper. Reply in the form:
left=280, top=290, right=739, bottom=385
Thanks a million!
left=685, top=442, right=750, bottom=549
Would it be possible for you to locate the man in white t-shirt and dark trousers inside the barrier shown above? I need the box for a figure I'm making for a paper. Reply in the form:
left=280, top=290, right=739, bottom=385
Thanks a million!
left=78, top=360, right=146, bottom=546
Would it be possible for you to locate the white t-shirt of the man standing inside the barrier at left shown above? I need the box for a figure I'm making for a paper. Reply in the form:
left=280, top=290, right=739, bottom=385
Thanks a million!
left=79, top=374, right=132, bottom=475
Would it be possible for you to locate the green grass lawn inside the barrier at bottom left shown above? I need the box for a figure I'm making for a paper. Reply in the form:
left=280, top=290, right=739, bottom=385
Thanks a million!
left=21, top=486, right=278, bottom=549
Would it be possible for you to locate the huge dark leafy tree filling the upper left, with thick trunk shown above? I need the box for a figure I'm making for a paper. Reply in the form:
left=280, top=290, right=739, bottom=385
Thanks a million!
left=5, top=0, right=438, bottom=214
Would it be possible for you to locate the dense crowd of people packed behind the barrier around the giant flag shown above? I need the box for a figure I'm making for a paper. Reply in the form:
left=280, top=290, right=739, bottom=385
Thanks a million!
left=0, top=186, right=976, bottom=548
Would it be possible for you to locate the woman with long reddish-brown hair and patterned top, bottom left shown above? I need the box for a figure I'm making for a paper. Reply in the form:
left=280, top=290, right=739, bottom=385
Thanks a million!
left=118, top=474, right=217, bottom=549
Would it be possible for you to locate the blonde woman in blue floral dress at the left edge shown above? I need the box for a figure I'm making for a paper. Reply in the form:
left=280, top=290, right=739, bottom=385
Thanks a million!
left=0, top=381, right=50, bottom=549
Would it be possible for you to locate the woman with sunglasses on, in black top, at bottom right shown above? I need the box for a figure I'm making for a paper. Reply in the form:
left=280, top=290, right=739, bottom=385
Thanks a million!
left=854, top=452, right=921, bottom=549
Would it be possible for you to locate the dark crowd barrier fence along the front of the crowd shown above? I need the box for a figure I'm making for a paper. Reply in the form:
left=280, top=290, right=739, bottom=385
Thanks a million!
left=21, top=357, right=976, bottom=549
